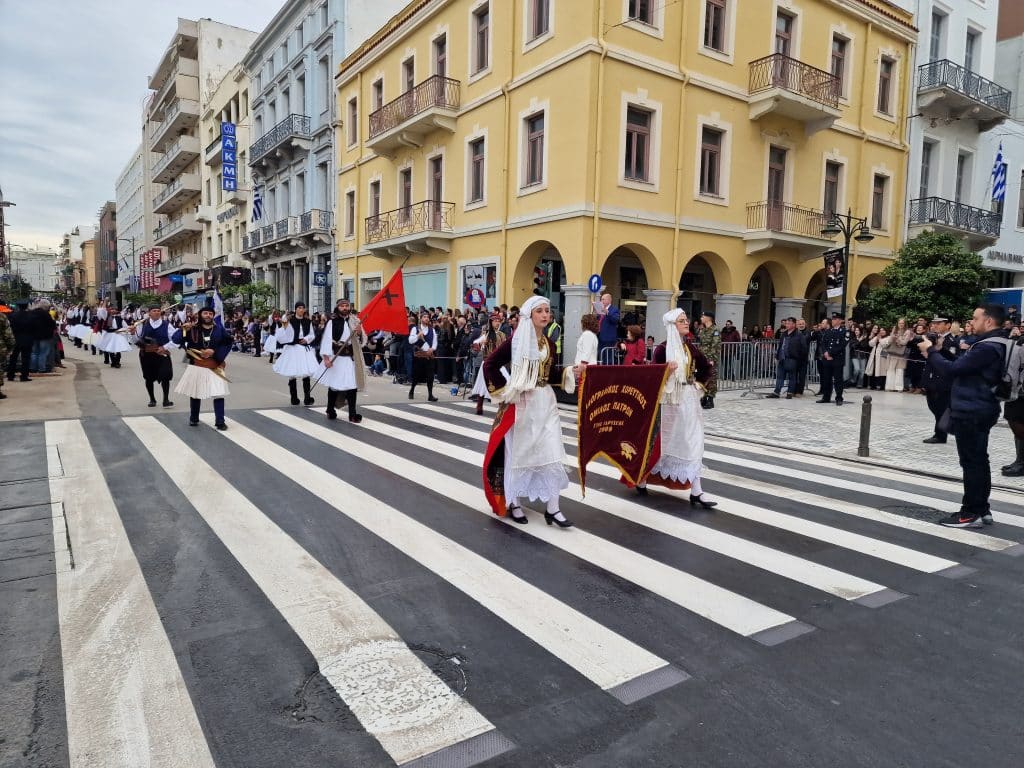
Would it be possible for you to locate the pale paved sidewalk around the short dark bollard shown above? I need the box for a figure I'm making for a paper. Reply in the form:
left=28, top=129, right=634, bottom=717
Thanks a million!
left=705, top=389, right=1024, bottom=492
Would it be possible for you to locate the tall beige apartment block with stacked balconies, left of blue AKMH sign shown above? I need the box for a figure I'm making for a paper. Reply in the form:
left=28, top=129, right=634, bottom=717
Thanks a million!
left=143, top=18, right=256, bottom=292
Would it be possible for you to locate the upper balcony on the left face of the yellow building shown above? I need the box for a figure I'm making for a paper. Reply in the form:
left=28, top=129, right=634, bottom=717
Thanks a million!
left=367, top=75, right=462, bottom=155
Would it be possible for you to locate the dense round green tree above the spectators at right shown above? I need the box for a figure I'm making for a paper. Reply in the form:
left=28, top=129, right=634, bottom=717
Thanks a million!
left=857, top=232, right=992, bottom=326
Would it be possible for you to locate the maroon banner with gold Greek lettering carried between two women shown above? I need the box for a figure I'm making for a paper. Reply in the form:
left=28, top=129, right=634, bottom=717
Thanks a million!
left=577, top=366, right=669, bottom=492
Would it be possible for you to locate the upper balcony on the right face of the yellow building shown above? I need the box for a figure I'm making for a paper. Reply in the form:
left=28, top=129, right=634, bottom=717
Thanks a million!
left=749, top=53, right=842, bottom=133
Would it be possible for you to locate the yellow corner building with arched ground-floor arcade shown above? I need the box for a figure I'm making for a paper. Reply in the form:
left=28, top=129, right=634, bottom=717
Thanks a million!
left=336, top=0, right=916, bottom=341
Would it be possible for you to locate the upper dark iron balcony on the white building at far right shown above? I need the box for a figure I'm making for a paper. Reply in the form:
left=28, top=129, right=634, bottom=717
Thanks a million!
left=918, top=58, right=1011, bottom=130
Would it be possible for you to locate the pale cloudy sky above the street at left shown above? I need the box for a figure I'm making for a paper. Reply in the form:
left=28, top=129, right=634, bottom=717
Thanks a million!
left=0, top=0, right=284, bottom=248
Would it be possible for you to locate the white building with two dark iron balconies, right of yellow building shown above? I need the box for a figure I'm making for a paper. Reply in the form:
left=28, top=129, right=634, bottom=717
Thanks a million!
left=907, top=0, right=1011, bottom=251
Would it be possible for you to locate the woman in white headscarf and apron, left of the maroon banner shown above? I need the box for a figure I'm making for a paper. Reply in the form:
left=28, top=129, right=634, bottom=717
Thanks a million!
left=483, top=296, right=572, bottom=528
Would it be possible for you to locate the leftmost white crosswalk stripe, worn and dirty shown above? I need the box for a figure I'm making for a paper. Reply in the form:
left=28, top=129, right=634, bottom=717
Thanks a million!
left=46, top=421, right=215, bottom=768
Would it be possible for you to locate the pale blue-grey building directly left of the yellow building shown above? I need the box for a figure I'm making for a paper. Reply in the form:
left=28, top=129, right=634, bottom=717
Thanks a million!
left=243, top=0, right=402, bottom=310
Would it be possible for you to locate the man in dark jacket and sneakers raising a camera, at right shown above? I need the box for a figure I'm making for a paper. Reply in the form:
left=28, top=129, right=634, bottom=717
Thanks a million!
left=918, top=304, right=1006, bottom=528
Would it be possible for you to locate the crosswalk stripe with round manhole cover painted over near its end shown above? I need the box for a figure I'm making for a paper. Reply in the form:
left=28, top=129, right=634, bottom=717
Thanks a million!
left=125, top=416, right=507, bottom=765
